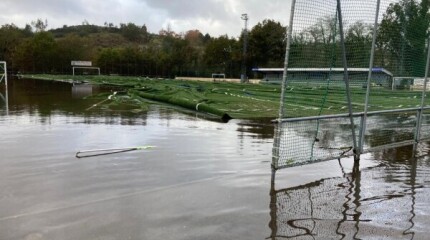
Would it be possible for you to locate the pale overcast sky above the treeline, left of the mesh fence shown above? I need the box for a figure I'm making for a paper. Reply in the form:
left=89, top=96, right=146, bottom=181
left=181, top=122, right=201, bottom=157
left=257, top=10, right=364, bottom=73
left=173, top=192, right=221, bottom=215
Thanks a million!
left=0, top=0, right=291, bottom=37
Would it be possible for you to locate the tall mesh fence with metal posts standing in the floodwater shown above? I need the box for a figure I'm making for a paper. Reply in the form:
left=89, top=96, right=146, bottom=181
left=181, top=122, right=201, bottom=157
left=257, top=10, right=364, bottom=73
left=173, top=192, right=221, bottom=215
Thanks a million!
left=272, top=0, right=430, bottom=169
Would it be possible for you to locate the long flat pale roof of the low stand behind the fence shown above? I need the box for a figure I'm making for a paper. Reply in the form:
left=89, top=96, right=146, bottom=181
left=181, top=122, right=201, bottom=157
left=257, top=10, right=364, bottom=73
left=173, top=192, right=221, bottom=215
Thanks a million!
left=252, top=68, right=393, bottom=76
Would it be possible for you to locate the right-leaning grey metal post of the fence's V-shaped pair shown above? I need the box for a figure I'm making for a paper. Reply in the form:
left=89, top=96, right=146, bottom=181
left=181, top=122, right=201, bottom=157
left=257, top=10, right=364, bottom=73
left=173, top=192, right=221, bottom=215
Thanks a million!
left=358, top=0, right=381, bottom=154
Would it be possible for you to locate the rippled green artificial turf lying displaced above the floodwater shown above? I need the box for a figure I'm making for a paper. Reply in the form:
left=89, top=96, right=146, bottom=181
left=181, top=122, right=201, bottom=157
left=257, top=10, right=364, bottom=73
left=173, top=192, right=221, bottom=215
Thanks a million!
left=25, top=75, right=430, bottom=119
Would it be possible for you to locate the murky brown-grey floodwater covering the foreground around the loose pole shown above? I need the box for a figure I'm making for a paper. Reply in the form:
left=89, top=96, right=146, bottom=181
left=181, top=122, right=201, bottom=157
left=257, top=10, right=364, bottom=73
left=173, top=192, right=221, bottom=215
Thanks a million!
left=0, top=79, right=430, bottom=240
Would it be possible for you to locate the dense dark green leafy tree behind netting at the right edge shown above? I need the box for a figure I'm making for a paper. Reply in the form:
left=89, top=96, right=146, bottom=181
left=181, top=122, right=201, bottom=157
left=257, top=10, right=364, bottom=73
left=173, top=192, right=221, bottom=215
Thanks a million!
left=378, top=0, right=430, bottom=76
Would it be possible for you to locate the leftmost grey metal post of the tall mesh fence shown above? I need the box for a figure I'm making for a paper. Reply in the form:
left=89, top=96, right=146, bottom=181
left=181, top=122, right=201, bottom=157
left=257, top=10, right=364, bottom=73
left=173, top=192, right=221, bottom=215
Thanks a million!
left=272, top=0, right=296, bottom=169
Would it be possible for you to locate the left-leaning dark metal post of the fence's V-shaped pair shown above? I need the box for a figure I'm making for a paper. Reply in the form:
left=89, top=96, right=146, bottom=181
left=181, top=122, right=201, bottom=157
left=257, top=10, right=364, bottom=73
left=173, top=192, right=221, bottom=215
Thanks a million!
left=337, top=0, right=360, bottom=161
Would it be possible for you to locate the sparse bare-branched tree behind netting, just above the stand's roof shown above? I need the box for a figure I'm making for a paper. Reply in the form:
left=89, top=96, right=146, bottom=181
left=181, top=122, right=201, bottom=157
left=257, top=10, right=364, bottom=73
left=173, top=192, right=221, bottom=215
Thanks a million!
left=289, top=15, right=372, bottom=68
